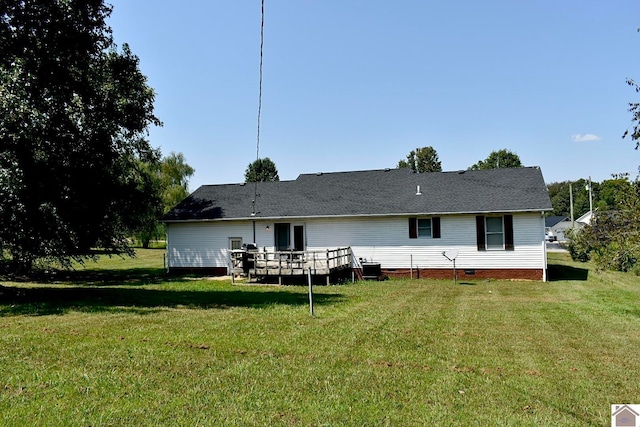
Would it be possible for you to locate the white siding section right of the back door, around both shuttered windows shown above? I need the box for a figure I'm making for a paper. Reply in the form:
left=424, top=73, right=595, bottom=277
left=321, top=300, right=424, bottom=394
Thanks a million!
left=307, top=213, right=545, bottom=269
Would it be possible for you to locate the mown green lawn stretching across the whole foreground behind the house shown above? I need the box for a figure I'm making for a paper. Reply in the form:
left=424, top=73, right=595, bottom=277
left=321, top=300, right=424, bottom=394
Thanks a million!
left=0, top=250, right=640, bottom=426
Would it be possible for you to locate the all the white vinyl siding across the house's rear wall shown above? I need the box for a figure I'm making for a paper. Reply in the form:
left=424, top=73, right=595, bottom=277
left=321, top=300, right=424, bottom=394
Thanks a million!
left=167, top=213, right=546, bottom=269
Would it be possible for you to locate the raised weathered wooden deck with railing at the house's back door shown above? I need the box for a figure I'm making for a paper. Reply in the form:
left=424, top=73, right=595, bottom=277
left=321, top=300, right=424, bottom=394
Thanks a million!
left=231, top=247, right=353, bottom=284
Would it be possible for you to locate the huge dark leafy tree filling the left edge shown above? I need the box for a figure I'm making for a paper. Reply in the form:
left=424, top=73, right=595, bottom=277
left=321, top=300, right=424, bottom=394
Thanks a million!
left=0, top=0, right=161, bottom=269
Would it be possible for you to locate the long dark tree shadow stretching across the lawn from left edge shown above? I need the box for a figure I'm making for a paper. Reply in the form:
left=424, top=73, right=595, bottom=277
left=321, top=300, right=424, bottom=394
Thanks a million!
left=0, top=285, right=342, bottom=316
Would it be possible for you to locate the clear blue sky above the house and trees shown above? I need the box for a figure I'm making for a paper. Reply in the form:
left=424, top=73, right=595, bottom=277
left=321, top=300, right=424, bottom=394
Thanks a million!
left=108, top=0, right=640, bottom=190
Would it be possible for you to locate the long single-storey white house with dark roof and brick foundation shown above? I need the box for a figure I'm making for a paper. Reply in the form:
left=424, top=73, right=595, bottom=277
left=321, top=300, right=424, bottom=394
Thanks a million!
left=163, top=167, right=552, bottom=280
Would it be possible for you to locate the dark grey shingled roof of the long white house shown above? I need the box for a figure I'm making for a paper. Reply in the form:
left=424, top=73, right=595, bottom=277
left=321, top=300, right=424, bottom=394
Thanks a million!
left=163, top=167, right=551, bottom=222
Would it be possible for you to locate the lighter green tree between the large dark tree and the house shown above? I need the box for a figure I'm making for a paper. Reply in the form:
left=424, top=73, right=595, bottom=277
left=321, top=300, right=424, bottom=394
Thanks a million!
left=134, top=152, right=195, bottom=248
